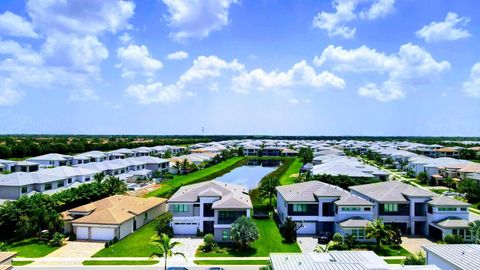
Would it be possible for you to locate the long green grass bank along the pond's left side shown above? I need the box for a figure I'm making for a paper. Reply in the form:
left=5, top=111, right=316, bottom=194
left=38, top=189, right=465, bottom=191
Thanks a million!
left=146, top=157, right=247, bottom=197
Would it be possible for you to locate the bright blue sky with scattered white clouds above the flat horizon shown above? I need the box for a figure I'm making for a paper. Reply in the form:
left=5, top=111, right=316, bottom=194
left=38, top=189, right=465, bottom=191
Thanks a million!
left=0, top=0, right=480, bottom=136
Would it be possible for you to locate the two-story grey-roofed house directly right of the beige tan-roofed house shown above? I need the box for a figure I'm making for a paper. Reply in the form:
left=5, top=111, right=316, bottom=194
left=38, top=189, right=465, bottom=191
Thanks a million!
left=168, top=180, right=253, bottom=241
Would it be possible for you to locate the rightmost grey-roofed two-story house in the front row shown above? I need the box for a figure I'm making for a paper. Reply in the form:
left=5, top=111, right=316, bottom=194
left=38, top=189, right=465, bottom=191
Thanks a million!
left=350, top=181, right=471, bottom=241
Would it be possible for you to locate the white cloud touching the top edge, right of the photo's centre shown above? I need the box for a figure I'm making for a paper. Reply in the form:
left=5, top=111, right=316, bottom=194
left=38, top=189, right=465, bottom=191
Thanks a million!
left=312, top=0, right=395, bottom=39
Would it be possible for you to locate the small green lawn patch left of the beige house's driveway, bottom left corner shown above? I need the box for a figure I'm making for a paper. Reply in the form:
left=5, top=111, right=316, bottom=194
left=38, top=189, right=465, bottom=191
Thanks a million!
left=6, top=238, right=59, bottom=258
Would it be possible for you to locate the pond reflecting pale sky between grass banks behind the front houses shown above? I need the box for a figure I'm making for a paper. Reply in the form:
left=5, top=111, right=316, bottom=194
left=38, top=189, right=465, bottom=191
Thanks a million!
left=215, top=160, right=280, bottom=189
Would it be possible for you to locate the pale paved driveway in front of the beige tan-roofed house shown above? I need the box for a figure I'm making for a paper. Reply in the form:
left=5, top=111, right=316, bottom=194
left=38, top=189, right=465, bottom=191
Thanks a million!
left=30, top=241, right=105, bottom=266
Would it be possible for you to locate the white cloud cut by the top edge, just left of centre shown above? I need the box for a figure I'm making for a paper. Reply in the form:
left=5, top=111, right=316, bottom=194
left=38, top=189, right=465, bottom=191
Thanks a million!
left=163, top=0, right=237, bottom=41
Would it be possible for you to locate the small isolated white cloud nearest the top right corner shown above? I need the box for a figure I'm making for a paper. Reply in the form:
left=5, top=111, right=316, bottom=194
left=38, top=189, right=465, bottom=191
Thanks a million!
left=416, top=12, right=470, bottom=42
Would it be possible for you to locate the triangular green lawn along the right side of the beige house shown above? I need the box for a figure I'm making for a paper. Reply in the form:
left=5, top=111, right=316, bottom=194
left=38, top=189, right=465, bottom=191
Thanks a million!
left=93, top=221, right=157, bottom=257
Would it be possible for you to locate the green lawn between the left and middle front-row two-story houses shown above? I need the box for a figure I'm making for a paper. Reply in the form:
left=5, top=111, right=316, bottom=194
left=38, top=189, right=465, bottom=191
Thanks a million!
left=197, top=218, right=301, bottom=257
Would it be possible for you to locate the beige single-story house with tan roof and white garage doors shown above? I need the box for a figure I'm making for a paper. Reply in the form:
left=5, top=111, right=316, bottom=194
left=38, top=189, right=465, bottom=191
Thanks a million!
left=64, top=195, right=167, bottom=241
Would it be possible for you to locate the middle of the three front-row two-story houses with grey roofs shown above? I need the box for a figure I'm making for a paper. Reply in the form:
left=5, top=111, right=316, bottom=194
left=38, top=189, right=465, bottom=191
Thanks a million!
left=277, top=181, right=373, bottom=241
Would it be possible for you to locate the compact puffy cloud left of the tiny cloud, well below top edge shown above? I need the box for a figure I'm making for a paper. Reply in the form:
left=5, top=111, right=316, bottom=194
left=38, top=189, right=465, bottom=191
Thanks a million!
left=115, top=45, right=163, bottom=79
